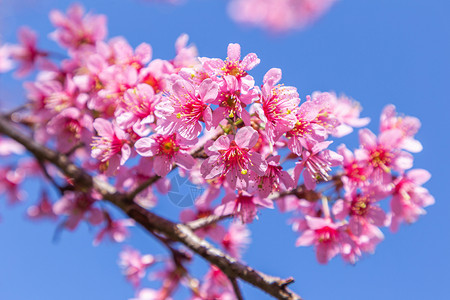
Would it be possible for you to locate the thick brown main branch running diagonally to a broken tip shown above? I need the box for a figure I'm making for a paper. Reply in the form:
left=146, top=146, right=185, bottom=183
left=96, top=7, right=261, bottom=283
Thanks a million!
left=0, top=116, right=301, bottom=300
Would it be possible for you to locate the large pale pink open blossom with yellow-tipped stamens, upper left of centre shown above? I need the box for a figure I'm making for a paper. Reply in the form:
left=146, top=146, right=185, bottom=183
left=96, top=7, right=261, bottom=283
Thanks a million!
left=156, top=79, right=219, bottom=140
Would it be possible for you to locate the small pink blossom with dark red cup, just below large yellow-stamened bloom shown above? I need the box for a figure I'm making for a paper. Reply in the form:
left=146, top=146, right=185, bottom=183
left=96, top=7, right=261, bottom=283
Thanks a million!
left=134, top=133, right=196, bottom=176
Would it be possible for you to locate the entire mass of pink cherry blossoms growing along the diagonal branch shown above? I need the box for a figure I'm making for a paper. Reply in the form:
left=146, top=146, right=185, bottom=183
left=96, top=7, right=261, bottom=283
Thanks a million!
left=0, top=1, right=434, bottom=300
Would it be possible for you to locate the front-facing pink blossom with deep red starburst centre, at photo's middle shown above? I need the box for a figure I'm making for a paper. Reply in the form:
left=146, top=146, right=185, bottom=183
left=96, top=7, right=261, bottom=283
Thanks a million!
left=201, top=126, right=267, bottom=189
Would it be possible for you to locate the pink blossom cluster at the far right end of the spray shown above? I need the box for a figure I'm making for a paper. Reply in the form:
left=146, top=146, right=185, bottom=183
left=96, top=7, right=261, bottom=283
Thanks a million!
left=280, top=105, right=434, bottom=263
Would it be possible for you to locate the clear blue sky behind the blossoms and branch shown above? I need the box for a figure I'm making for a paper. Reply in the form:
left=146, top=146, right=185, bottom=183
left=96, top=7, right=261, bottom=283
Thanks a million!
left=0, top=0, right=450, bottom=300
